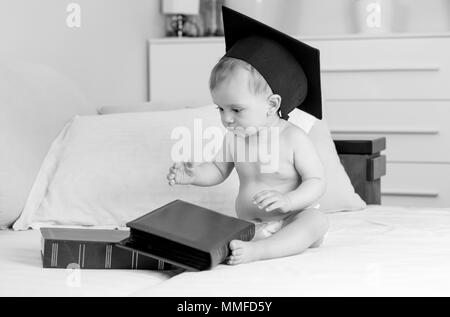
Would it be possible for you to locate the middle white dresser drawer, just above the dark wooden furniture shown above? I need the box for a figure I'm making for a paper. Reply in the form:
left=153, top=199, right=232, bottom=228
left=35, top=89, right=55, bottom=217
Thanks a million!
left=324, top=100, right=450, bottom=163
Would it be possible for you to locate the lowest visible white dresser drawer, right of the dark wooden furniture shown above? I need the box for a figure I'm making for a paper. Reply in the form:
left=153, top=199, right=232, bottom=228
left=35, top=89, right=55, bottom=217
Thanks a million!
left=381, top=163, right=450, bottom=207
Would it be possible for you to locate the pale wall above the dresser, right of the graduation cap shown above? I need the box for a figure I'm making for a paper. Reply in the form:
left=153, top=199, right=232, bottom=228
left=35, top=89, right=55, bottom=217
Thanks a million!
left=226, top=0, right=450, bottom=35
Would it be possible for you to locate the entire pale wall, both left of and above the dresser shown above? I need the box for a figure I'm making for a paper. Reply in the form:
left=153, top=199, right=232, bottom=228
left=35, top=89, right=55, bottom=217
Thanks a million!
left=0, top=0, right=450, bottom=106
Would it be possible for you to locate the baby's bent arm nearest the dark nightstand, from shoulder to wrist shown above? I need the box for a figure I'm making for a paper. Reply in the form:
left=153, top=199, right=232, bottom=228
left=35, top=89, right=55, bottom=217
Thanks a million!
left=286, top=129, right=326, bottom=211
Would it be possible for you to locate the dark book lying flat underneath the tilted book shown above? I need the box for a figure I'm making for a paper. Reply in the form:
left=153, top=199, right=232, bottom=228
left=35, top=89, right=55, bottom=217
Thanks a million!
left=41, top=228, right=173, bottom=270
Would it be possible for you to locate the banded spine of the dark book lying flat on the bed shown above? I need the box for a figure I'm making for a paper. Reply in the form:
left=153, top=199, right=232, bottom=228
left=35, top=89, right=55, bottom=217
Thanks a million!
left=41, top=240, right=173, bottom=270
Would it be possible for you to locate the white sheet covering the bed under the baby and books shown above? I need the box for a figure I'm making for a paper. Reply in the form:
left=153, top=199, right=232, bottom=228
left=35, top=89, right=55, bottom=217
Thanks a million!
left=0, top=206, right=450, bottom=297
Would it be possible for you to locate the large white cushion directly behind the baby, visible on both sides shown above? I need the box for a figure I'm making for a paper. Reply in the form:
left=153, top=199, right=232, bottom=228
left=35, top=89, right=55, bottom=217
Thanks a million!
left=14, top=105, right=365, bottom=230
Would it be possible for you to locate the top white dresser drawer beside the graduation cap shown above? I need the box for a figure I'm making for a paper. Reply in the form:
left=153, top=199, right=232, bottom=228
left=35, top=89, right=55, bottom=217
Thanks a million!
left=310, top=38, right=450, bottom=98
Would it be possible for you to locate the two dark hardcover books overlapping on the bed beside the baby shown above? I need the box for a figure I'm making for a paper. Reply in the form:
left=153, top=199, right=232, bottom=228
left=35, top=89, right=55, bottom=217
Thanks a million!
left=41, top=200, right=255, bottom=271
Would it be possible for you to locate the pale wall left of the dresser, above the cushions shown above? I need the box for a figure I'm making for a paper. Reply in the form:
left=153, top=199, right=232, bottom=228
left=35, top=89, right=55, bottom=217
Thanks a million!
left=0, top=0, right=164, bottom=106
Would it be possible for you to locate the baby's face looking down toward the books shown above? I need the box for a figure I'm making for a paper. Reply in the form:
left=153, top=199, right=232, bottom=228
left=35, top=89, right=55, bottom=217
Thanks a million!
left=211, top=69, right=269, bottom=136
